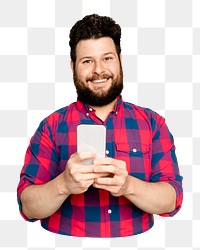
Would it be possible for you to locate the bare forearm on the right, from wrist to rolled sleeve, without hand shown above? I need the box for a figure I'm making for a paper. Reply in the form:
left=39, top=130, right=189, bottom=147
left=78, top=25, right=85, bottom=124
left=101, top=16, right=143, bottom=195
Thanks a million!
left=124, top=176, right=176, bottom=214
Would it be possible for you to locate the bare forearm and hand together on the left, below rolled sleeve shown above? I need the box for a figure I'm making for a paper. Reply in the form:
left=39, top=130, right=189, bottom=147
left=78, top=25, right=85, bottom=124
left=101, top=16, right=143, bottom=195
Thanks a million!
left=20, top=150, right=109, bottom=219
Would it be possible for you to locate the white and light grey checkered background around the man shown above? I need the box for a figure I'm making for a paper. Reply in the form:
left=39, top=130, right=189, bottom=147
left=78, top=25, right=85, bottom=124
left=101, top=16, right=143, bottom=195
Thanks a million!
left=0, top=0, right=200, bottom=250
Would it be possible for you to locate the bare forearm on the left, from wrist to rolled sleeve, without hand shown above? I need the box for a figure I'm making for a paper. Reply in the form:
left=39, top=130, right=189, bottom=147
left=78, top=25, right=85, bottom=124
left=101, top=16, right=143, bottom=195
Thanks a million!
left=20, top=174, right=69, bottom=219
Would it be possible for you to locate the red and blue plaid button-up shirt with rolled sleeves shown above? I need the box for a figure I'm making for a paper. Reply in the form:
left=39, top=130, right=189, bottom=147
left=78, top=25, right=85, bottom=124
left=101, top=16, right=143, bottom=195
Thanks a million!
left=18, top=96, right=183, bottom=237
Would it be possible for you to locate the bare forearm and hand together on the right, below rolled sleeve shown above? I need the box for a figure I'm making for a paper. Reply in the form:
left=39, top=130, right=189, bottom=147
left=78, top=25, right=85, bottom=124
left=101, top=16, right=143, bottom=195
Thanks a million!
left=93, top=158, right=176, bottom=214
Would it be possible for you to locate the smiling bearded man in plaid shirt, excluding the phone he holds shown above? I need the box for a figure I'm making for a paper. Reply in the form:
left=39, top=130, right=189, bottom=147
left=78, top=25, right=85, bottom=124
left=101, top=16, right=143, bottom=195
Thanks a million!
left=18, top=15, right=182, bottom=237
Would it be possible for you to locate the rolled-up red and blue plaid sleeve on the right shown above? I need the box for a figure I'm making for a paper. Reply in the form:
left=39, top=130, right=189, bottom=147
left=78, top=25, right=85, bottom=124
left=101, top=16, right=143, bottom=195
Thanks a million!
left=150, top=115, right=183, bottom=217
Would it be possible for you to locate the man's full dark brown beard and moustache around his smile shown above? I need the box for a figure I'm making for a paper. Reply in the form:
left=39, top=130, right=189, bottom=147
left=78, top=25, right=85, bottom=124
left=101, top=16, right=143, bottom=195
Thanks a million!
left=73, top=64, right=123, bottom=107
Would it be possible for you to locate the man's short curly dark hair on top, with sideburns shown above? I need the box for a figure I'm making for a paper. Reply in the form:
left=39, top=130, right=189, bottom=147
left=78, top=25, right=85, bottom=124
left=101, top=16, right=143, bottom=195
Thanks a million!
left=69, top=14, right=121, bottom=63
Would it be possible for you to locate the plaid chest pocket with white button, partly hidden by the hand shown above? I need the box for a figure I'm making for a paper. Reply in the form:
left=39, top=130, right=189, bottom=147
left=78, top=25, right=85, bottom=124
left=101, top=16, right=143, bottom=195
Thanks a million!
left=116, top=141, right=151, bottom=181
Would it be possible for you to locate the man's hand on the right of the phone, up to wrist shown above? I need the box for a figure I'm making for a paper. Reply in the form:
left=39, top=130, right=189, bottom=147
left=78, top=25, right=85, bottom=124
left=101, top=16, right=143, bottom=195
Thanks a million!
left=93, top=158, right=128, bottom=196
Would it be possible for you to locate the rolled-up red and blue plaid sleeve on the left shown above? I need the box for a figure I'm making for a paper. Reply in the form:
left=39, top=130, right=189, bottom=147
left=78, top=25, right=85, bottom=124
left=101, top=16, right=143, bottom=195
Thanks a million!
left=17, top=121, right=59, bottom=222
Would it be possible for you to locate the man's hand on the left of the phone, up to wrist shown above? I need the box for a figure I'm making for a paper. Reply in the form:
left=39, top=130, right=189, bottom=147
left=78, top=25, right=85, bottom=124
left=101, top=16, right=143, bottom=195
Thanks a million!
left=63, top=152, right=108, bottom=195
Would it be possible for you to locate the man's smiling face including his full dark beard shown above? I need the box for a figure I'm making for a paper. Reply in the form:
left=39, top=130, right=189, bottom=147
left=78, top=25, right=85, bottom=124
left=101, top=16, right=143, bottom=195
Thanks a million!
left=72, top=37, right=123, bottom=106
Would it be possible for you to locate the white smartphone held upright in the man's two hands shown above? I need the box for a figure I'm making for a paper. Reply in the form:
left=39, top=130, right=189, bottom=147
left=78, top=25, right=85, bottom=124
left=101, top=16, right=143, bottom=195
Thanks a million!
left=77, top=124, right=106, bottom=165
